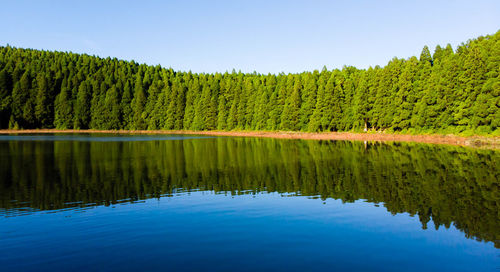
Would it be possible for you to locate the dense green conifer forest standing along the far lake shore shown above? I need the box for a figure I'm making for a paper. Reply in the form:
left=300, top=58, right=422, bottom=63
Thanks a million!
left=0, top=31, right=500, bottom=135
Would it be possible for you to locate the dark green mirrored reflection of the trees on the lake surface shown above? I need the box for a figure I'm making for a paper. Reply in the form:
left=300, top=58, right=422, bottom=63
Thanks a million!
left=0, top=136, right=500, bottom=247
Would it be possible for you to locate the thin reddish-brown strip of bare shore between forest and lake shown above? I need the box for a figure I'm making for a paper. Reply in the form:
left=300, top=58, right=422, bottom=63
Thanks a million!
left=0, top=129, right=500, bottom=149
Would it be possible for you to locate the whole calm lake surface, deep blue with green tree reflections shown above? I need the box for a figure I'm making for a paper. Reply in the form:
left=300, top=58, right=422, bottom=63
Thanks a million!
left=0, top=134, right=500, bottom=271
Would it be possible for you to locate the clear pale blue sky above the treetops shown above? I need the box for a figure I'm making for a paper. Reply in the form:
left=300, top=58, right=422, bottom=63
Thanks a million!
left=0, top=0, right=500, bottom=73
